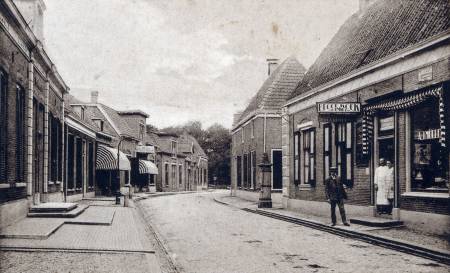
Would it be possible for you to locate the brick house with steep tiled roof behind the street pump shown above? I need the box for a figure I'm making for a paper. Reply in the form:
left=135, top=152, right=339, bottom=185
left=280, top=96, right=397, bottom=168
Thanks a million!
left=231, top=57, right=305, bottom=200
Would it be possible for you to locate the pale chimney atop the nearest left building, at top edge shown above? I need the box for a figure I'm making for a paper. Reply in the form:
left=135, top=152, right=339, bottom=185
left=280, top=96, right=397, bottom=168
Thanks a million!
left=13, top=0, right=46, bottom=44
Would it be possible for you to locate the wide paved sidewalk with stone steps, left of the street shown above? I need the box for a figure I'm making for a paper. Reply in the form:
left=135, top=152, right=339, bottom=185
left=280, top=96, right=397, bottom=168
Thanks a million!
left=0, top=200, right=161, bottom=273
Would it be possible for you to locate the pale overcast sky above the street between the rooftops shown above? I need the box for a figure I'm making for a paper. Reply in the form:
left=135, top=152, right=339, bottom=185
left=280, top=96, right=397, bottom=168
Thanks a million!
left=45, top=0, right=358, bottom=128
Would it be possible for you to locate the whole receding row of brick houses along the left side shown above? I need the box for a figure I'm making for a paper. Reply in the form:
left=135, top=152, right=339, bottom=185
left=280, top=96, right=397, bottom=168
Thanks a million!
left=0, top=0, right=208, bottom=227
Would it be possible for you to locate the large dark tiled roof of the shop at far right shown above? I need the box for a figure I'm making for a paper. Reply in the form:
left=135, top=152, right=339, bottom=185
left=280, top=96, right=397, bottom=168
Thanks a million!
left=291, top=0, right=450, bottom=98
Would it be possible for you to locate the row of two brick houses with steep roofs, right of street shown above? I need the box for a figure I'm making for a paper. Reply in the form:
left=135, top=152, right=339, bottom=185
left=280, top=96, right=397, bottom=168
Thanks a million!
left=231, top=0, right=450, bottom=234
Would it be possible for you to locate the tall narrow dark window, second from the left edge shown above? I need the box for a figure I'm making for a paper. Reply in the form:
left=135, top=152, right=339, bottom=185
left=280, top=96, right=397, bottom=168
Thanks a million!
left=16, top=85, right=26, bottom=182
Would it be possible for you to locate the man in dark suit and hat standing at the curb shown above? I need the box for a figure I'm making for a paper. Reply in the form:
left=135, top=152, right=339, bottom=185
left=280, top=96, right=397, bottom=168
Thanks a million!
left=325, top=167, right=350, bottom=226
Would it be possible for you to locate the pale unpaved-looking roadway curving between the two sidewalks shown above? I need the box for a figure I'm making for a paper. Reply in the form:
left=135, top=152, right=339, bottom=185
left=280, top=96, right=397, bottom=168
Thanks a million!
left=140, top=190, right=450, bottom=273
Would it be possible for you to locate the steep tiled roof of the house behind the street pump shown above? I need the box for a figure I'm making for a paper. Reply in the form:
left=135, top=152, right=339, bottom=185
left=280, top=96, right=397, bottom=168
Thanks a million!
left=238, top=57, right=305, bottom=126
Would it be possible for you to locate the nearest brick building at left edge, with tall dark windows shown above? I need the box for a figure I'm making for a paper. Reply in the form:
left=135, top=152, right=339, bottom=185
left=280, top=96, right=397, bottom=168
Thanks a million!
left=0, top=0, right=68, bottom=226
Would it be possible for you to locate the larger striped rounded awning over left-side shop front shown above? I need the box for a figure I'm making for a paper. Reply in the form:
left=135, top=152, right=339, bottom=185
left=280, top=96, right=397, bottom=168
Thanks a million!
left=96, top=145, right=131, bottom=171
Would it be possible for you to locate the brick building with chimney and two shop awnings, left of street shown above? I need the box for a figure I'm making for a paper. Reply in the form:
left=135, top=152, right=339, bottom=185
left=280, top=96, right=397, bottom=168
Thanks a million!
left=71, top=91, right=156, bottom=195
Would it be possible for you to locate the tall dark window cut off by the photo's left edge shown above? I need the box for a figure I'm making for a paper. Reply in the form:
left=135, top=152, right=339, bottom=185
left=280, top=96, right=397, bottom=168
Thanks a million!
left=0, top=70, right=8, bottom=183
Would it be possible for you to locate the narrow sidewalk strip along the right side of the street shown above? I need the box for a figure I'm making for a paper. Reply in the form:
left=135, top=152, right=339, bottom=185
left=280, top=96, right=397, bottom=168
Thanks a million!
left=215, top=193, right=450, bottom=255
